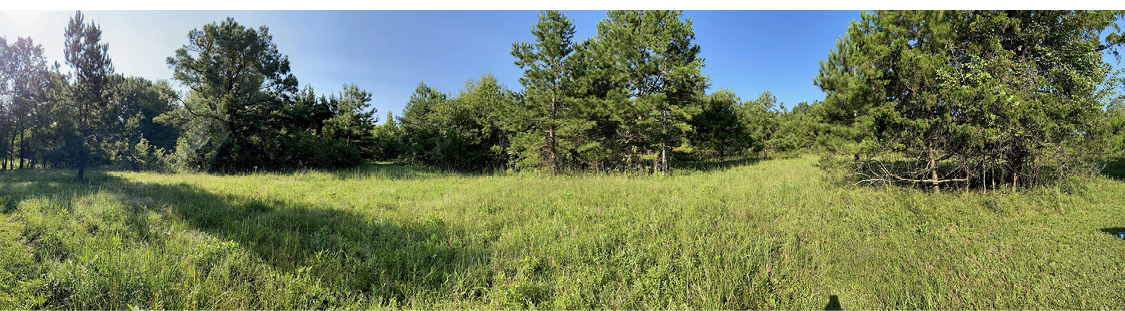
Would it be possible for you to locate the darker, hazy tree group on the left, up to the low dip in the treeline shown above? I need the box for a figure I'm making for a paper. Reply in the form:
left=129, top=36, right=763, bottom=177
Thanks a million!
left=0, top=11, right=377, bottom=178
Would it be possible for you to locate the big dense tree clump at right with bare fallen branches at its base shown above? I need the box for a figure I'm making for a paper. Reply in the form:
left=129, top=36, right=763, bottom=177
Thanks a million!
left=826, top=11, right=1122, bottom=192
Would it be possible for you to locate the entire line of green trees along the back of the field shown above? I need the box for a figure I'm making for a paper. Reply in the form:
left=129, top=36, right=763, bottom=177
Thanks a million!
left=0, top=10, right=1125, bottom=190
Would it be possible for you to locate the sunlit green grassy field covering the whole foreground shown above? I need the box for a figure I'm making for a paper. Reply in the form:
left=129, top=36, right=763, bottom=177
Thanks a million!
left=0, top=158, right=1125, bottom=310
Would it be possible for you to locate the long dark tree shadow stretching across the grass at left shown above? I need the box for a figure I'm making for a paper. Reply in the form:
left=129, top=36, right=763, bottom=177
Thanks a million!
left=0, top=170, right=491, bottom=302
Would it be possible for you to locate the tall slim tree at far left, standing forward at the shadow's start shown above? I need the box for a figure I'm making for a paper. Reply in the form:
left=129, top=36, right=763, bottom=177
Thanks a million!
left=63, top=11, right=114, bottom=179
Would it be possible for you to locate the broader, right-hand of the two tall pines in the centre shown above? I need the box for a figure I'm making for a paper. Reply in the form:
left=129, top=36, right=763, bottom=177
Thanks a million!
left=597, top=11, right=708, bottom=172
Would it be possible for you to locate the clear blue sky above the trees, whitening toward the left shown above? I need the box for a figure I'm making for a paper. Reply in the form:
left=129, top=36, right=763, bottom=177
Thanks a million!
left=0, top=10, right=860, bottom=123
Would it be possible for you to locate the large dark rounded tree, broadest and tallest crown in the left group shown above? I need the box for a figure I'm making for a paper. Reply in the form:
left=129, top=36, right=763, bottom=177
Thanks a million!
left=168, top=18, right=297, bottom=170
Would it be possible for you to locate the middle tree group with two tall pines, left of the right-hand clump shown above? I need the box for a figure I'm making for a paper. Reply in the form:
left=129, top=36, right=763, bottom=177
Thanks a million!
left=376, top=11, right=818, bottom=174
